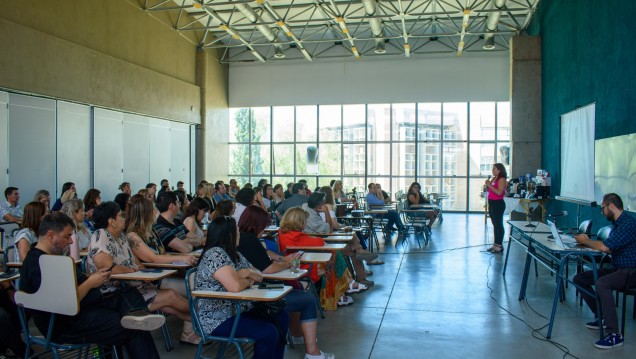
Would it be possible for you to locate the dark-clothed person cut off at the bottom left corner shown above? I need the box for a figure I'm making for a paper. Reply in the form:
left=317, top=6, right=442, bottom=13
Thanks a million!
left=0, top=282, right=26, bottom=358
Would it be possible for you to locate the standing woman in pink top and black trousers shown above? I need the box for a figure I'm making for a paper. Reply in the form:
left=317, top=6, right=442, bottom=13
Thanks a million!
left=485, top=163, right=508, bottom=253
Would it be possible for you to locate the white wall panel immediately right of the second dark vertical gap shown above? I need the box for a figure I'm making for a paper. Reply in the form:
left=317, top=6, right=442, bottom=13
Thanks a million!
left=94, top=108, right=124, bottom=201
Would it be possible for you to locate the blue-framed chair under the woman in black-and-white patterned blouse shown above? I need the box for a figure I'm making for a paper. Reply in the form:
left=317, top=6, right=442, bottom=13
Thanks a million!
left=185, top=267, right=254, bottom=359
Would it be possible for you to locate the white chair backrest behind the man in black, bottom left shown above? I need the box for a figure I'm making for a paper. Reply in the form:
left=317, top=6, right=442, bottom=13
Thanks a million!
left=15, top=255, right=79, bottom=315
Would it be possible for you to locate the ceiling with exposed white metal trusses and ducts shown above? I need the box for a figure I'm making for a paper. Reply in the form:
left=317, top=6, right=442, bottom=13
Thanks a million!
left=139, top=0, right=540, bottom=63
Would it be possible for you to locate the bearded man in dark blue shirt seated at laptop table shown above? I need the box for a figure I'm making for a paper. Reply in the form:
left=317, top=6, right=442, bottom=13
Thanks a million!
left=574, top=193, right=636, bottom=349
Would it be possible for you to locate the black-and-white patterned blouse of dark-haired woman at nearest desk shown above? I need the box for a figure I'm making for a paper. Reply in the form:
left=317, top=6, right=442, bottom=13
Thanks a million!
left=194, top=247, right=252, bottom=334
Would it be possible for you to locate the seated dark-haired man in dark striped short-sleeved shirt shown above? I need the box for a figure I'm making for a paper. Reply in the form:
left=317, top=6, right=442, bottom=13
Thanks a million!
left=154, top=192, right=194, bottom=253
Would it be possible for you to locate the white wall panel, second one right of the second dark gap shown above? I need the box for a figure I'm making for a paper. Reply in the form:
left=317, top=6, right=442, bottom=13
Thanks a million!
left=122, top=113, right=150, bottom=194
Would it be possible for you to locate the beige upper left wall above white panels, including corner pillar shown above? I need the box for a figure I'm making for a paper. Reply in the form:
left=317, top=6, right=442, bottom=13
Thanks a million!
left=0, top=0, right=228, bottom=179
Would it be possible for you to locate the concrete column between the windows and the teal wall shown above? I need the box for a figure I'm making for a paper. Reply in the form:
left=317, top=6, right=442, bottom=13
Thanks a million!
left=509, top=36, right=541, bottom=178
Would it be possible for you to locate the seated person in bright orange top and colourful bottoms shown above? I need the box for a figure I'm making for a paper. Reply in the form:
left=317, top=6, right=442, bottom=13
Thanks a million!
left=278, top=207, right=356, bottom=310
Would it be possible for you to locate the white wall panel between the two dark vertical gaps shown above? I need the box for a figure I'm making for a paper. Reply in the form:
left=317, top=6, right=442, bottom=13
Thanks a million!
left=56, top=101, right=92, bottom=198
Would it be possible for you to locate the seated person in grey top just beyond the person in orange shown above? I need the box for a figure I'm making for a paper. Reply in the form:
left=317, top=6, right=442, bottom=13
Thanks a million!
left=301, top=192, right=378, bottom=291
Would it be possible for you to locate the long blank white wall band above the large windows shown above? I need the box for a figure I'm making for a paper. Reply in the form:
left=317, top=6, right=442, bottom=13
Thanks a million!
left=229, top=51, right=510, bottom=107
